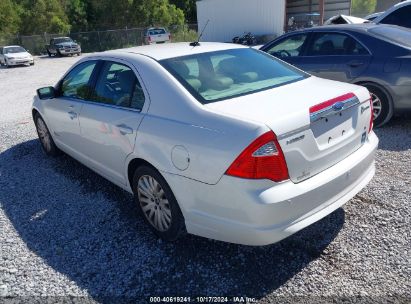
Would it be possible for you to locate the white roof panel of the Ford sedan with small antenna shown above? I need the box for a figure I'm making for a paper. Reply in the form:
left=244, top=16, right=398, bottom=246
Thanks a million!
left=104, top=42, right=249, bottom=60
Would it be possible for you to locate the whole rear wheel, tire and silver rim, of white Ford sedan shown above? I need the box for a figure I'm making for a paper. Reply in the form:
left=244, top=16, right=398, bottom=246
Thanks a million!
left=133, top=166, right=185, bottom=241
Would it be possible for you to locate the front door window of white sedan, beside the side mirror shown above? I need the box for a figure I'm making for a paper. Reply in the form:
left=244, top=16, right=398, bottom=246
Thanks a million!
left=61, top=61, right=96, bottom=99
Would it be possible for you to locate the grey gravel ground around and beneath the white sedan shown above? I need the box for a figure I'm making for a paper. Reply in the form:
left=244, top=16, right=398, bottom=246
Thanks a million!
left=0, top=57, right=411, bottom=303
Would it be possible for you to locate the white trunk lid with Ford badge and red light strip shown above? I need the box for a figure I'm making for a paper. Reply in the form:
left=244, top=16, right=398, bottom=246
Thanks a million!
left=206, top=77, right=371, bottom=183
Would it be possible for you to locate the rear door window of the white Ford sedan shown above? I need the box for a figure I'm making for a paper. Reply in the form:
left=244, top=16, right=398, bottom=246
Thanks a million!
left=91, top=61, right=145, bottom=111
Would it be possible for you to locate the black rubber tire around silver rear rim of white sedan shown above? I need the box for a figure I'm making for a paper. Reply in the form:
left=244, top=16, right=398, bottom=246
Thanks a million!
left=132, top=165, right=186, bottom=241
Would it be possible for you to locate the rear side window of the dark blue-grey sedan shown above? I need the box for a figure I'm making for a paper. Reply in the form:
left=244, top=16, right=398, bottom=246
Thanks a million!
left=307, top=33, right=368, bottom=56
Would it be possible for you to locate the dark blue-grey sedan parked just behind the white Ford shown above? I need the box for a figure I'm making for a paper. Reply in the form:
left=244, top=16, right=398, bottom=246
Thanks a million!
left=261, top=23, right=411, bottom=126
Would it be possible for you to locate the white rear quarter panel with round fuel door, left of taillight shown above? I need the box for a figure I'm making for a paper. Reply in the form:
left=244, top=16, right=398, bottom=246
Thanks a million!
left=128, top=56, right=268, bottom=184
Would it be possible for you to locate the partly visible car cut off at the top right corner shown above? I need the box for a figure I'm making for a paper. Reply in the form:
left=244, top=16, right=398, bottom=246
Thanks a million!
left=373, top=0, right=411, bottom=28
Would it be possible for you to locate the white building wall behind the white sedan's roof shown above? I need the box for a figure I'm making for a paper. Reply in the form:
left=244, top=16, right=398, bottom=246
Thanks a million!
left=197, top=0, right=285, bottom=42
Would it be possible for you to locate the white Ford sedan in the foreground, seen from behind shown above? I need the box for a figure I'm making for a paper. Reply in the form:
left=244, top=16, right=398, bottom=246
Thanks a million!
left=32, top=43, right=378, bottom=245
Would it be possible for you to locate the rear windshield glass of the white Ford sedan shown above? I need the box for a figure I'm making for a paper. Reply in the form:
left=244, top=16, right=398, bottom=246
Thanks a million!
left=160, top=48, right=309, bottom=104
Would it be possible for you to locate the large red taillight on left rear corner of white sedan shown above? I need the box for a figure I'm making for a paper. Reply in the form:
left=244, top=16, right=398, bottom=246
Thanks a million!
left=226, top=131, right=289, bottom=182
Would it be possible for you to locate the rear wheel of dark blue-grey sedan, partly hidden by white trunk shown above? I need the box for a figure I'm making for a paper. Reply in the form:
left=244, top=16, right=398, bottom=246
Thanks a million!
left=362, top=83, right=393, bottom=128
